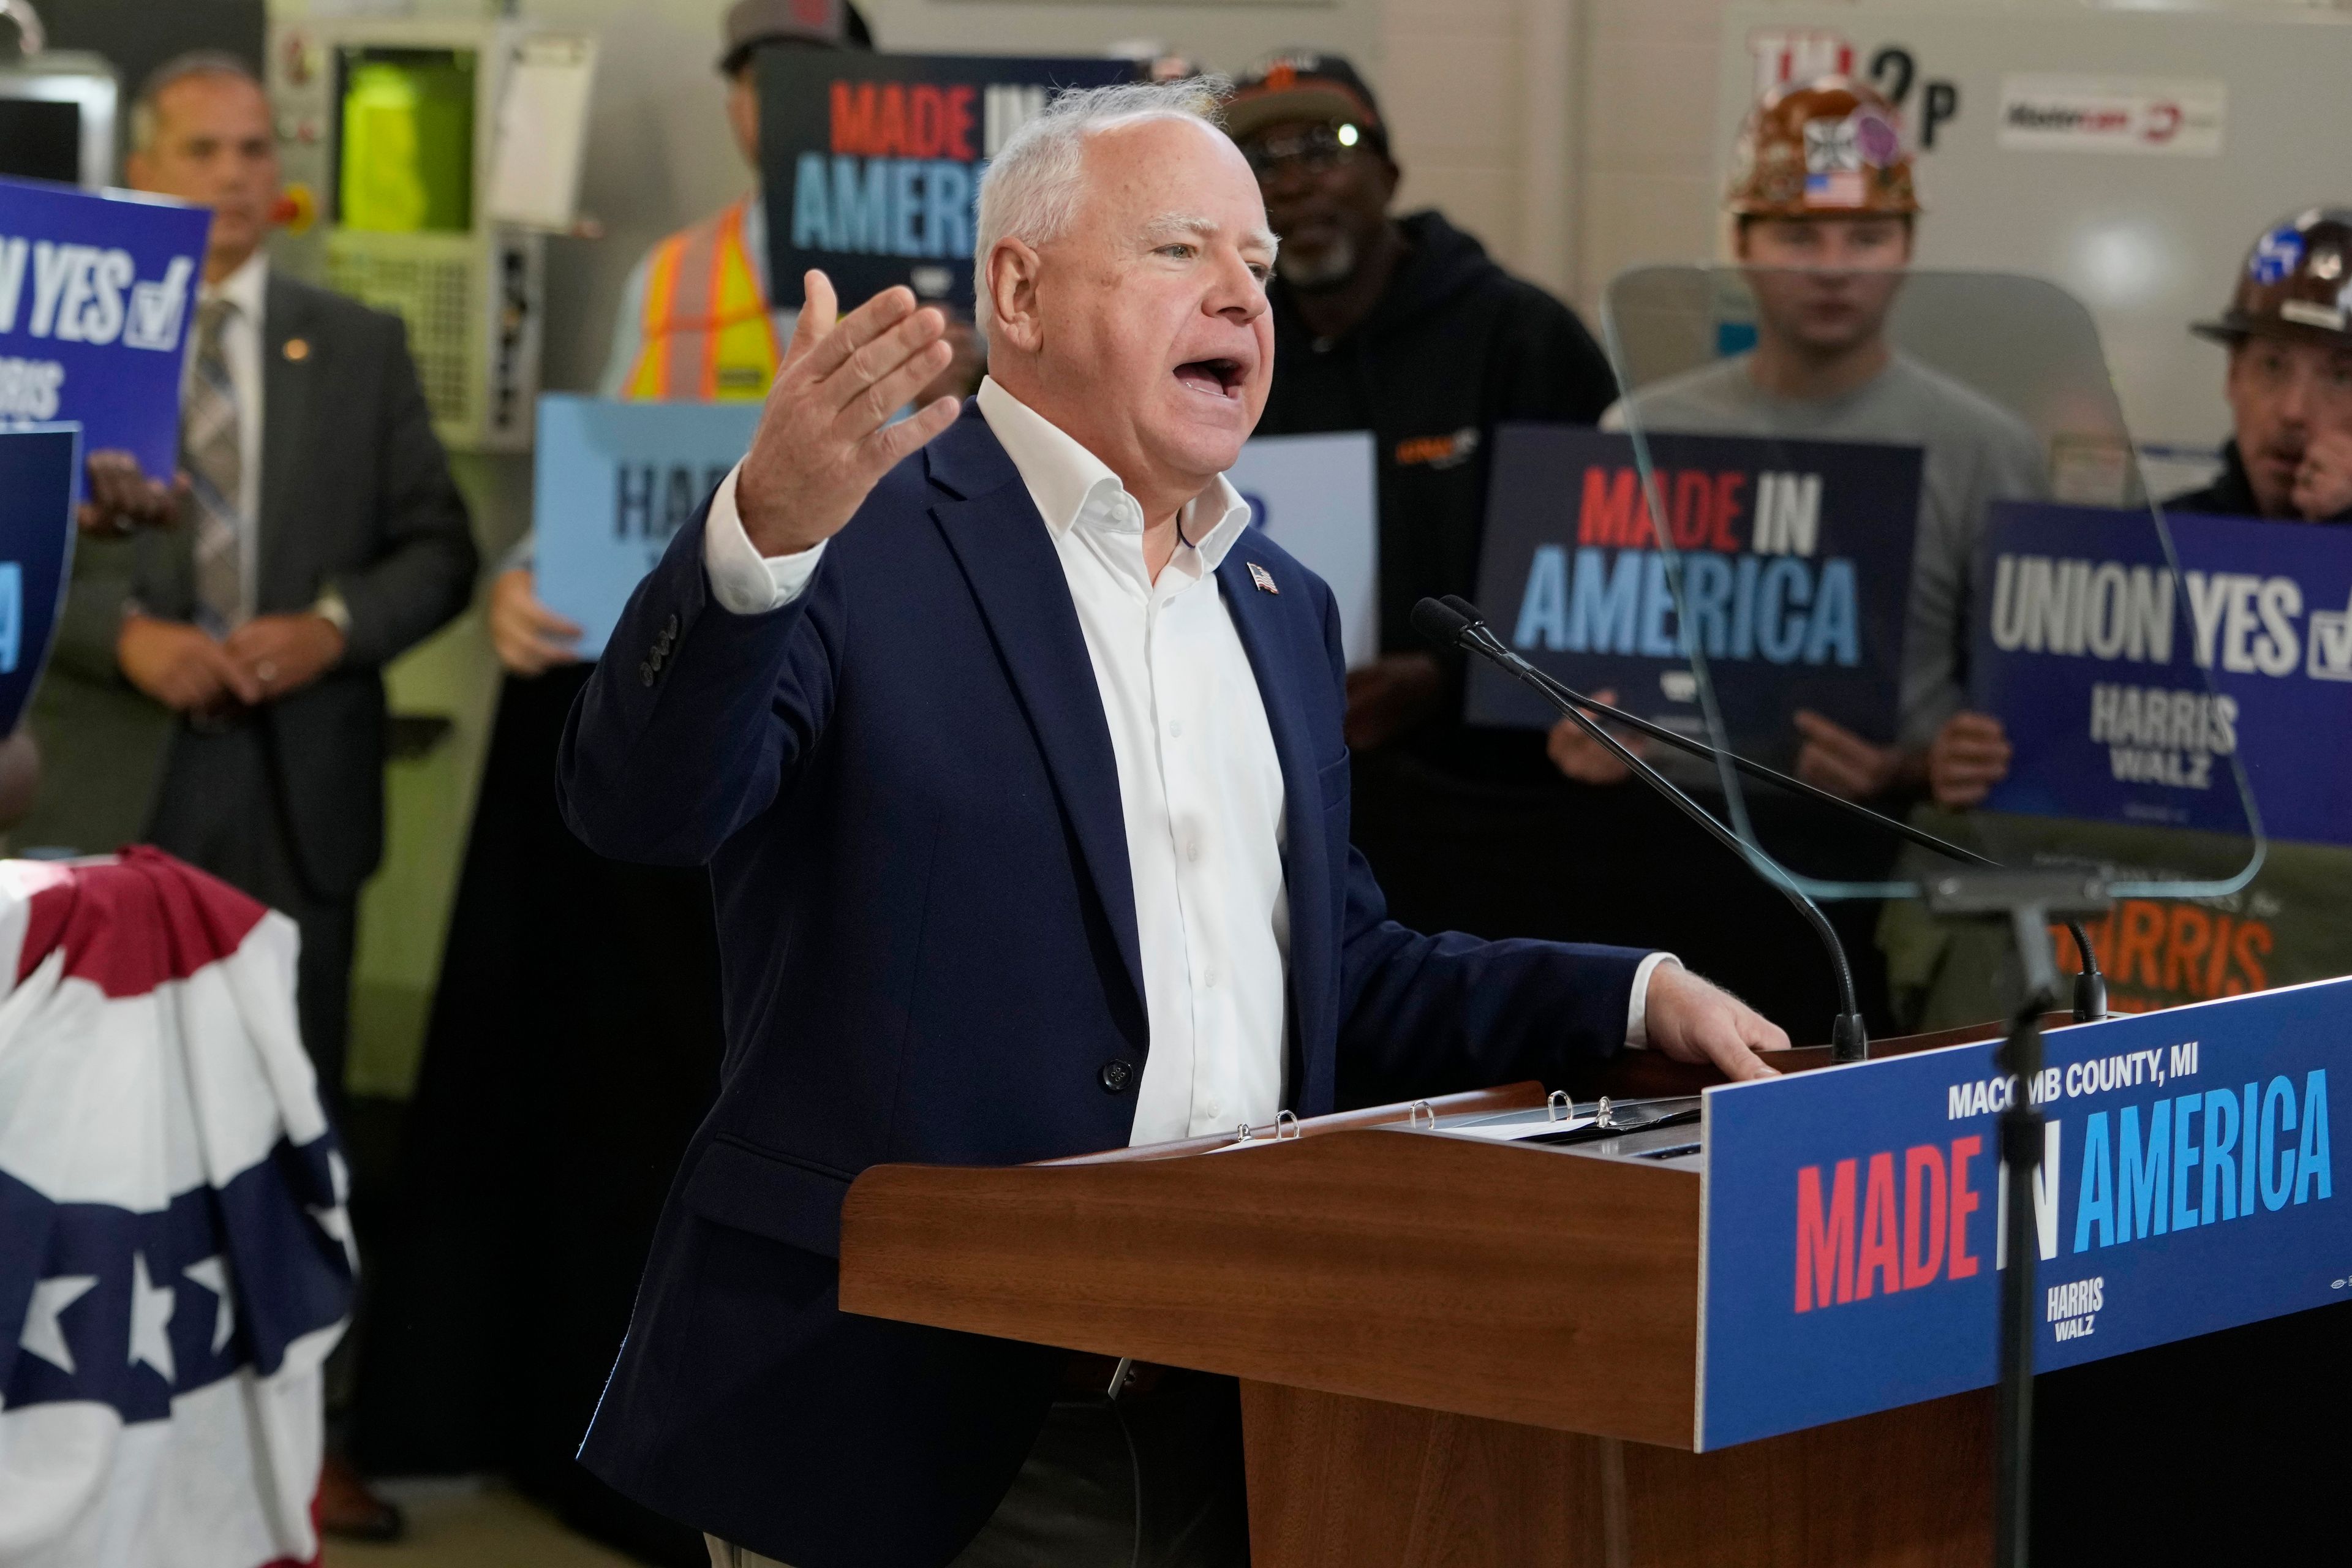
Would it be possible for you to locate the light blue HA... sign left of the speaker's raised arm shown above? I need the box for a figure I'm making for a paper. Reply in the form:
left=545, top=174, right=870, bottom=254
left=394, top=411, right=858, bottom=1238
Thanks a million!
left=532, top=393, right=762, bottom=658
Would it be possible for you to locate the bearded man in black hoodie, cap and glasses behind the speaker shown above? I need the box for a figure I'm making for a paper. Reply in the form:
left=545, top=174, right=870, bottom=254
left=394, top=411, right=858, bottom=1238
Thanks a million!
left=1226, top=50, right=1616, bottom=936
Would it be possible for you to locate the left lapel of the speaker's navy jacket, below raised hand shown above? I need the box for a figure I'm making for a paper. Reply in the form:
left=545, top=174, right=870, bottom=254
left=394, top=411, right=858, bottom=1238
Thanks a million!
left=924, top=402, right=1143, bottom=1020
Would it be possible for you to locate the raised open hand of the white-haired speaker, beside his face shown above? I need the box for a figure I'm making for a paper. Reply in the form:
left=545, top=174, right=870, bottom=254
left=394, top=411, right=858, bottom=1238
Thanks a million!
left=736, top=270, right=957, bottom=555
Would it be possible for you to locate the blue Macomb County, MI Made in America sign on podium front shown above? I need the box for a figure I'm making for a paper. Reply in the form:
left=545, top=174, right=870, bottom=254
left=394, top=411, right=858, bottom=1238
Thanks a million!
left=1700, top=980, right=2352, bottom=1448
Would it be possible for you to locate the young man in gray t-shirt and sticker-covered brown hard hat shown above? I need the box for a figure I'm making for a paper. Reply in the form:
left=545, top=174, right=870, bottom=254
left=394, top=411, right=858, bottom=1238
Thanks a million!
left=1550, top=78, right=2044, bottom=806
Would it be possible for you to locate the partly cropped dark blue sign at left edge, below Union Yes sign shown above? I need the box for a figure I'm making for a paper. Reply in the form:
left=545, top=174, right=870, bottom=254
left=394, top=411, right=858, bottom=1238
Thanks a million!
left=0, top=426, right=82, bottom=736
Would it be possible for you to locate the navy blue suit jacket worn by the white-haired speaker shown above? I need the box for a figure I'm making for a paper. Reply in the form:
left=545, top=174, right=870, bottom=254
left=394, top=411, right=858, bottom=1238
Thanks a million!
left=560, top=404, right=1642, bottom=1568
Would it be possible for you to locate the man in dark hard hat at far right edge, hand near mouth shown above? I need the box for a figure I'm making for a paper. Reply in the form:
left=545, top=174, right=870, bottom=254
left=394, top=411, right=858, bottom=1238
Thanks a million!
left=2166, top=207, right=2352, bottom=522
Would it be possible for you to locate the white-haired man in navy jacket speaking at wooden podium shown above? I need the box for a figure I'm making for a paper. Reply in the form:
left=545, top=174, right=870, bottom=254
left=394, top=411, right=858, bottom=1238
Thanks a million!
left=560, top=82, right=1785, bottom=1568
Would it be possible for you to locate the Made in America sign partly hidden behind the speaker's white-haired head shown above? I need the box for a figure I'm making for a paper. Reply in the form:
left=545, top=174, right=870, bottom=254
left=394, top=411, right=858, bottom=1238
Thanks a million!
left=760, top=50, right=1134, bottom=311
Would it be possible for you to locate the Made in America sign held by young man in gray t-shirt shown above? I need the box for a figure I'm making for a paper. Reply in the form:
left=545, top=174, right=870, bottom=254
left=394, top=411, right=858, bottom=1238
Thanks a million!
left=1468, top=426, right=1919, bottom=750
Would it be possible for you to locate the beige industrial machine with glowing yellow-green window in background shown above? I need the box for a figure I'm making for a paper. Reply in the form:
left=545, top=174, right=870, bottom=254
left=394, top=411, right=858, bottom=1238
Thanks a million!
left=268, top=17, right=595, bottom=451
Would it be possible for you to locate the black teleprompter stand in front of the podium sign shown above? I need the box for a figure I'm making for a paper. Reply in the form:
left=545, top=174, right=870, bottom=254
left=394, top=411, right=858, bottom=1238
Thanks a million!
left=1926, top=870, right=2114, bottom=1568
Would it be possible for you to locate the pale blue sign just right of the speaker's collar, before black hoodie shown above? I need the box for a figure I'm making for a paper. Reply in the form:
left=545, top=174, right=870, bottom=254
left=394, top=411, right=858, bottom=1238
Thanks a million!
left=1226, top=430, right=1381, bottom=670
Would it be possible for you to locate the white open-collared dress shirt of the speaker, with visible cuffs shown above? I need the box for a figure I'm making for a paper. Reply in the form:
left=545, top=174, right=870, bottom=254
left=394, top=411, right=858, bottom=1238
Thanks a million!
left=703, top=376, right=1663, bottom=1145
